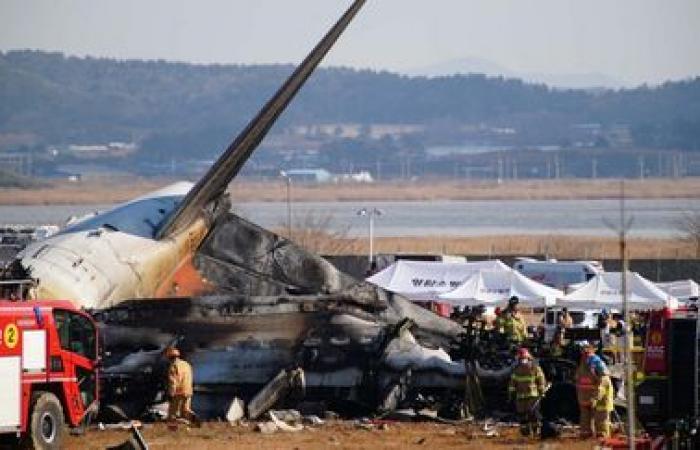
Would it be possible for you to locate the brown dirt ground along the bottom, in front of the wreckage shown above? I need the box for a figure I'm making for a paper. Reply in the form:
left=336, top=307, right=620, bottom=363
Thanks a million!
left=66, top=421, right=596, bottom=450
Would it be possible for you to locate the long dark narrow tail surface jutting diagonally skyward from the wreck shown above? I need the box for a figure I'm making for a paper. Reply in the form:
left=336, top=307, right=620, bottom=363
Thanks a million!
left=156, top=0, right=365, bottom=239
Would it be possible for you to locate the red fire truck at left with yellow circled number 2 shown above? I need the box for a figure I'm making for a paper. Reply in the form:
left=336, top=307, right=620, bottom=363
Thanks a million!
left=0, top=300, right=98, bottom=449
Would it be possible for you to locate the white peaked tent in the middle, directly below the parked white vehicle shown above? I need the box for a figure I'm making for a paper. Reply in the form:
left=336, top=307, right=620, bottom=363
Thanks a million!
left=440, top=269, right=564, bottom=307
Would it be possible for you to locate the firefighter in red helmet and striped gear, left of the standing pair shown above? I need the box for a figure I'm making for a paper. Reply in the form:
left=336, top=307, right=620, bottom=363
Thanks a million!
left=508, top=347, right=546, bottom=436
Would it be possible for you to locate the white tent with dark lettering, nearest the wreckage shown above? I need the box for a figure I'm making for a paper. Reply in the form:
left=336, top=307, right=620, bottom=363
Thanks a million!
left=367, top=260, right=510, bottom=301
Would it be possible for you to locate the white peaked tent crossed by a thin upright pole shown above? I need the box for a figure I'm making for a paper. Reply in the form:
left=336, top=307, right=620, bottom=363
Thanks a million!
left=557, top=272, right=677, bottom=310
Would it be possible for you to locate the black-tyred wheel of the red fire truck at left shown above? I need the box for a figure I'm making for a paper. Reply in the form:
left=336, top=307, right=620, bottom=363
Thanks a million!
left=24, top=392, right=65, bottom=450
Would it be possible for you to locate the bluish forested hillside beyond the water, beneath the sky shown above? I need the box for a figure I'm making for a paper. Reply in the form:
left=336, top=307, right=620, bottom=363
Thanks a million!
left=0, top=51, right=700, bottom=155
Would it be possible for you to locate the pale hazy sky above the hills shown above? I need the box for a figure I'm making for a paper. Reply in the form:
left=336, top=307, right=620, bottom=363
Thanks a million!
left=0, top=0, right=700, bottom=83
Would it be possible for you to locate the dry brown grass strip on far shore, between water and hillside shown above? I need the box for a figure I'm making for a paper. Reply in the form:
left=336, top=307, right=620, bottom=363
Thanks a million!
left=0, top=178, right=700, bottom=205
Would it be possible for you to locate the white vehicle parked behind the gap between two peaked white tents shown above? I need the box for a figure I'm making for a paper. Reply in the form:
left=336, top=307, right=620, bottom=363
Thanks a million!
left=513, top=258, right=604, bottom=294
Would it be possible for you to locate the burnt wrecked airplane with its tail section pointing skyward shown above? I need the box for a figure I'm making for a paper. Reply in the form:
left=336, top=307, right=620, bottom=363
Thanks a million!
left=5, top=0, right=510, bottom=417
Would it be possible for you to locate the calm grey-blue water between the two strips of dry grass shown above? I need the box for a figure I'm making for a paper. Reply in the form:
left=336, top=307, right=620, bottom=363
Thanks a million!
left=0, top=199, right=700, bottom=237
